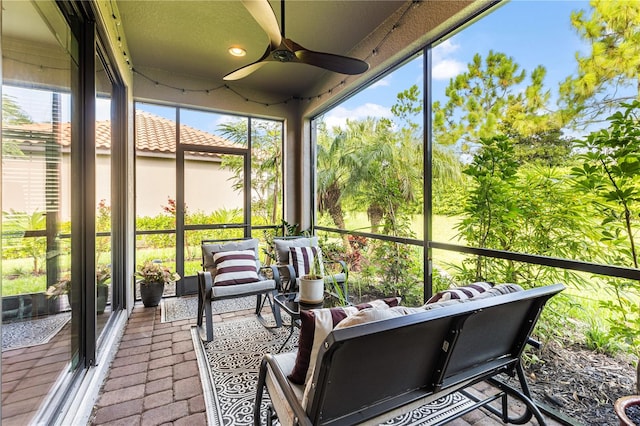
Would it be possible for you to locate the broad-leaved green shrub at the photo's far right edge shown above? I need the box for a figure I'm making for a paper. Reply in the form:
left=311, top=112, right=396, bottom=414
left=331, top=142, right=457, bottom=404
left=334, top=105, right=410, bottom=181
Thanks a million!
left=573, top=101, right=640, bottom=370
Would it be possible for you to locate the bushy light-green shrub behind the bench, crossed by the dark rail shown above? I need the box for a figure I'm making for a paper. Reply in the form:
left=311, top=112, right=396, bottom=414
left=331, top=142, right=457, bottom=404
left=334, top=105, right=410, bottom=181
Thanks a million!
left=457, top=136, right=596, bottom=286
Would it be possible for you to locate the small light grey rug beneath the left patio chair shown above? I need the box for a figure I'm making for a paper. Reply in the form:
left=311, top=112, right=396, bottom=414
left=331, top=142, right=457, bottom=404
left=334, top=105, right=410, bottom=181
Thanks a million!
left=160, top=296, right=256, bottom=322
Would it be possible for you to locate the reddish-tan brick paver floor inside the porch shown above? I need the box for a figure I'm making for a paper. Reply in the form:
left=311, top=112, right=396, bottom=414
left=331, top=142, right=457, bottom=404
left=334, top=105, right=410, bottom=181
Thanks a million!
left=90, top=300, right=558, bottom=426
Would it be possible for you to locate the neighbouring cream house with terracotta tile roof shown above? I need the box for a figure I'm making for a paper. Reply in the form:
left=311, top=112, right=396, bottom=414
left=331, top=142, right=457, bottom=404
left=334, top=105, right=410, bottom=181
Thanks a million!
left=2, top=111, right=242, bottom=221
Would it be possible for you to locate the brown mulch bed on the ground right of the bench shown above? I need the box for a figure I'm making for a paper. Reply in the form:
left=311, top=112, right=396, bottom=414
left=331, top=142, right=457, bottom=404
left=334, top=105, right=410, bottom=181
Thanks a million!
left=525, top=342, right=636, bottom=425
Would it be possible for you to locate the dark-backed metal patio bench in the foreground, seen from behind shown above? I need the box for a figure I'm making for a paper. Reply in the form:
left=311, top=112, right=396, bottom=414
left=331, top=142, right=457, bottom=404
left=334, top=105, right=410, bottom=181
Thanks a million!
left=254, top=284, right=564, bottom=425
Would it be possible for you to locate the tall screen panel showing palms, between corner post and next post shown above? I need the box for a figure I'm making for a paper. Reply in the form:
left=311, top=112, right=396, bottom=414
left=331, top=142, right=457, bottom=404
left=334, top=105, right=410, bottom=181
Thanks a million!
left=315, top=56, right=424, bottom=237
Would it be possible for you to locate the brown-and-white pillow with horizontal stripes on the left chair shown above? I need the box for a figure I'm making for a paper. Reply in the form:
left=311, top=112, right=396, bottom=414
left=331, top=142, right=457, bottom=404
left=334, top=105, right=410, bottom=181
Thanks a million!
left=213, top=250, right=260, bottom=286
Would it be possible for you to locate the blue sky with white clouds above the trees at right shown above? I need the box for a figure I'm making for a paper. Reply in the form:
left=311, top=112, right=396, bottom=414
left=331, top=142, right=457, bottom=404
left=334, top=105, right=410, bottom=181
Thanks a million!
left=325, top=1, right=589, bottom=130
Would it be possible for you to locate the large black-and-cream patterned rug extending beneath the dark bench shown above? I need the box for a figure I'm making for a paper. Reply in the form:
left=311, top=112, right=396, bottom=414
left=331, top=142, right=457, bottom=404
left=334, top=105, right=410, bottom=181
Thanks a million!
left=194, top=318, right=472, bottom=426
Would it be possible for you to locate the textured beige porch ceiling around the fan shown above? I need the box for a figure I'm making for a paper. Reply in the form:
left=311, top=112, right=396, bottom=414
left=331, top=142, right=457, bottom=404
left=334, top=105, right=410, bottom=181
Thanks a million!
left=116, top=0, right=406, bottom=96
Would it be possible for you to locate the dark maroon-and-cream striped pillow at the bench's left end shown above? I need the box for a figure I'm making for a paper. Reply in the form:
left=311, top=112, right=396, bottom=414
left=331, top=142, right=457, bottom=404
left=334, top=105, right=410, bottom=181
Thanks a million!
left=287, top=297, right=400, bottom=385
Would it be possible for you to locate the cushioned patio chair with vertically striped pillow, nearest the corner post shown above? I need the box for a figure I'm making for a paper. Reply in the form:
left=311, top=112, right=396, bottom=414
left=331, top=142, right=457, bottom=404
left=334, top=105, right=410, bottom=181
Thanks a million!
left=273, top=236, right=349, bottom=300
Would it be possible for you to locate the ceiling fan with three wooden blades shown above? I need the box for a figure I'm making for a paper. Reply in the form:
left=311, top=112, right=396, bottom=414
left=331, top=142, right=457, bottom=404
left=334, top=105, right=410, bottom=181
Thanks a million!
left=223, top=0, right=369, bottom=80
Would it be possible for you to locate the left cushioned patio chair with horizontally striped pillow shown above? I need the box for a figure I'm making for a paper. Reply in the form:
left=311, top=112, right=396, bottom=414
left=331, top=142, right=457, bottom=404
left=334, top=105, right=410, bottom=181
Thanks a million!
left=197, top=239, right=282, bottom=342
